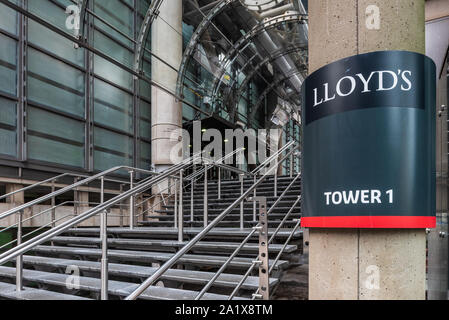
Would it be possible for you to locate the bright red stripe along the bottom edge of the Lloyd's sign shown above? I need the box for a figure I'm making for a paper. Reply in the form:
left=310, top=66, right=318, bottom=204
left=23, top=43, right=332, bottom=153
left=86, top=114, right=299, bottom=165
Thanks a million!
left=301, top=216, right=437, bottom=229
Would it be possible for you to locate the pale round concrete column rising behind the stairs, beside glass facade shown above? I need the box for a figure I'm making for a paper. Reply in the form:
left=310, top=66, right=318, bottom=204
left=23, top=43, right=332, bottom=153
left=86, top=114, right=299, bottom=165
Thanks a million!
left=151, top=1, right=182, bottom=171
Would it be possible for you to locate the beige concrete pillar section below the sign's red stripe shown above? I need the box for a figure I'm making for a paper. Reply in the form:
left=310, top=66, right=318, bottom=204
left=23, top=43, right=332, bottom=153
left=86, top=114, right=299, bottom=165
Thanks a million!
left=309, top=229, right=426, bottom=300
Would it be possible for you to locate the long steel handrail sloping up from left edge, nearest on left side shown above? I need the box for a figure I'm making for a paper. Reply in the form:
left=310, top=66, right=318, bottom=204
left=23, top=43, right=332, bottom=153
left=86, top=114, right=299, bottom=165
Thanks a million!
left=0, top=159, right=198, bottom=265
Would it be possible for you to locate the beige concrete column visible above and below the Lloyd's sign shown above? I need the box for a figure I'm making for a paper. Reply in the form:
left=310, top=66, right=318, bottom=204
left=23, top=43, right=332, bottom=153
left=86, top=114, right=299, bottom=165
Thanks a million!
left=309, top=0, right=426, bottom=300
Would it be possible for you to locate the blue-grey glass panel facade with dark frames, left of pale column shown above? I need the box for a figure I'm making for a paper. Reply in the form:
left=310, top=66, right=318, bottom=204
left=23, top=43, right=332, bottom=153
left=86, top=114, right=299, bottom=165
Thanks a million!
left=0, top=0, right=151, bottom=172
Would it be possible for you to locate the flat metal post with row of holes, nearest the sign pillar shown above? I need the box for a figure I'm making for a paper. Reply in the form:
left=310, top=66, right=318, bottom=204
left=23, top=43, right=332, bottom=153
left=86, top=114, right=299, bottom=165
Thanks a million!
left=258, top=197, right=270, bottom=300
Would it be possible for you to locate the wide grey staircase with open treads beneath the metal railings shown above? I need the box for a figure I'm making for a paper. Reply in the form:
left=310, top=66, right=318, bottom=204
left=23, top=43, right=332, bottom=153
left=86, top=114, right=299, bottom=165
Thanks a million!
left=0, top=146, right=302, bottom=300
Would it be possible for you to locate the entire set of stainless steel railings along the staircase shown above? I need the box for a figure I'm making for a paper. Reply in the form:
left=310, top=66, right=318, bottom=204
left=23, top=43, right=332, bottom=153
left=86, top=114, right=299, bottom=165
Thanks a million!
left=0, top=142, right=299, bottom=300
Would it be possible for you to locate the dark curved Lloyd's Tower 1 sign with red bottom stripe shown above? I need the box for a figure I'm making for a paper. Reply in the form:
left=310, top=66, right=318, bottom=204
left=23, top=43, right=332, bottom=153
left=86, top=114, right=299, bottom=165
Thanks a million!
left=301, top=51, right=436, bottom=228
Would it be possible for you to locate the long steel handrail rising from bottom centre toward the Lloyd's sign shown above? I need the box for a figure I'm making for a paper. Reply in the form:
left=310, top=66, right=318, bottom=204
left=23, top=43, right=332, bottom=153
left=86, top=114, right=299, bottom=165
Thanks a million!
left=124, top=144, right=299, bottom=300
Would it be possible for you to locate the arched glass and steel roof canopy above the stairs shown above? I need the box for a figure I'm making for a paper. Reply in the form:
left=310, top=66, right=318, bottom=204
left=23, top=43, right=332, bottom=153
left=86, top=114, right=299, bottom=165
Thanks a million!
left=177, top=0, right=308, bottom=127
